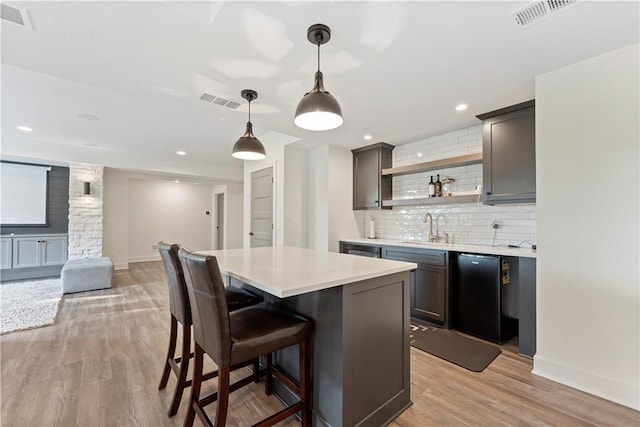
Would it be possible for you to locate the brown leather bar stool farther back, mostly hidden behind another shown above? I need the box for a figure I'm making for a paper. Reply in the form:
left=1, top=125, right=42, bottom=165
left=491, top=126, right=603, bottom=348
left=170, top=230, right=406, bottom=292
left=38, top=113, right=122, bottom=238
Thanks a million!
left=158, top=242, right=262, bottom=417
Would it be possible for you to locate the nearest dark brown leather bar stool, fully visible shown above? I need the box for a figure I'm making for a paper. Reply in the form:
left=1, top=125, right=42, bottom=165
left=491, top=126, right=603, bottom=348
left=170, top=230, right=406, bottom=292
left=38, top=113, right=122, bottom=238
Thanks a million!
left=178, top=249, right=312, bottom=427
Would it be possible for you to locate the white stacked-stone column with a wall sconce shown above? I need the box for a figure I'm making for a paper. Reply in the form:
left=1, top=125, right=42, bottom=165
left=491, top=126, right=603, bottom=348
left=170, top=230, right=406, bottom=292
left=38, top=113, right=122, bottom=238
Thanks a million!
left=69, top=163, right=104, bottom=259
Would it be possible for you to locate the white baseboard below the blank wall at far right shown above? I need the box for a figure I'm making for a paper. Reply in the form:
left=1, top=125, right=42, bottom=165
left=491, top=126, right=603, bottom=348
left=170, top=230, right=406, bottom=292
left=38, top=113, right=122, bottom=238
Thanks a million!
left=531, top=354, right=640, bottom=410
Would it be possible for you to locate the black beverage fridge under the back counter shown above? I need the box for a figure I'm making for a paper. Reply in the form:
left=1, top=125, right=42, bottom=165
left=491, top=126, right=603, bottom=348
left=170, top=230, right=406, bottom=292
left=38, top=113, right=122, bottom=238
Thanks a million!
left=453, top=253, right=517, bottom=344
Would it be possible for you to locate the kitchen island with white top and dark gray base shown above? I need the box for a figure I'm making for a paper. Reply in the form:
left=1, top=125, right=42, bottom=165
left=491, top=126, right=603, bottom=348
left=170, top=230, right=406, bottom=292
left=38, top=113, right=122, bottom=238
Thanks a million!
left=199, top=247, right=416, bottom=426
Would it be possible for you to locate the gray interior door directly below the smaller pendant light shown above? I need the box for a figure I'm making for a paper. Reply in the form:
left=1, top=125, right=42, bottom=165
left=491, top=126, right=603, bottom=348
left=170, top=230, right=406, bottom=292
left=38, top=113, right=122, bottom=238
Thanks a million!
left=249, top=167, right=273, bottom=248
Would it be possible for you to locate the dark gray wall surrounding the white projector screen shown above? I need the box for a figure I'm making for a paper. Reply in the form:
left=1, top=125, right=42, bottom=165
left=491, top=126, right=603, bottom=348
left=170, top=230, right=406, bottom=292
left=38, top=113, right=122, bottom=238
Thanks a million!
left=0, top=166, right=69, bottom=235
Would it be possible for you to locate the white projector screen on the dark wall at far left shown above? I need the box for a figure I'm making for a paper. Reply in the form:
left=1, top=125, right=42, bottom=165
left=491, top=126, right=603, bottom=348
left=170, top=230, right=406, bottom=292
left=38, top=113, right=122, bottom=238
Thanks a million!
left=0, top=162, right=51, bottom=225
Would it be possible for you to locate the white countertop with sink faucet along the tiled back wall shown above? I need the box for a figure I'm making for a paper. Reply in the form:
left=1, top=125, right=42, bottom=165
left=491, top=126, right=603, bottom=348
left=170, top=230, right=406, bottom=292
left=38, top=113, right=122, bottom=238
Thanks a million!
left=342, top=238, right=536, bottom=258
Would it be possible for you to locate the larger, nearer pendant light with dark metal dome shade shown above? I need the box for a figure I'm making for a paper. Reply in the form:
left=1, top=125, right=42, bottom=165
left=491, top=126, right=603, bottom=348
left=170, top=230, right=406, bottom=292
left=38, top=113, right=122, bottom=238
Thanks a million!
left=294, top=24, right=343, bottom=130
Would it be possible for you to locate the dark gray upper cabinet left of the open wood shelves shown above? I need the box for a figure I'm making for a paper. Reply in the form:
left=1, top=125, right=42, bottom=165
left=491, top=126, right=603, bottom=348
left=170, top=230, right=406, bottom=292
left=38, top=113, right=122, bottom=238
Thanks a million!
left=351, top=142, right=395, bottom=210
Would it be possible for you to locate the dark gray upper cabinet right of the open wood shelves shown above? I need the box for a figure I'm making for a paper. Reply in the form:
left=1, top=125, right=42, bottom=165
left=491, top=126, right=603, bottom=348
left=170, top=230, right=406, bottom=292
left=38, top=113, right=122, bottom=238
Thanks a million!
left=476, top=100, right=536, bottom=205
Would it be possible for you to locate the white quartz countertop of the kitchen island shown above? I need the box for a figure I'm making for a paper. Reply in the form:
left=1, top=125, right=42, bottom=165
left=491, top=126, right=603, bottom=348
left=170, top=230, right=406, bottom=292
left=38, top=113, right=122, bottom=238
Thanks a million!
left=198, top=246, right=418, bottom=298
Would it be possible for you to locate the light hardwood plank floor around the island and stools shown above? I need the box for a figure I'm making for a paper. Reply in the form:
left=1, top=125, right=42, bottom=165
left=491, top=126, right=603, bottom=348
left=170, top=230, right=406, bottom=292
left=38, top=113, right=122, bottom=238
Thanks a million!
left=0, top=262, right=640, bottom=427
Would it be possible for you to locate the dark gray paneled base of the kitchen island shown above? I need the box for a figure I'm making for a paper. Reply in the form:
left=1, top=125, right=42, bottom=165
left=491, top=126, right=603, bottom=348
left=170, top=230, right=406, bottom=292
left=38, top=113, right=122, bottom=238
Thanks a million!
left=229, top=271, right=411, bottom=427
